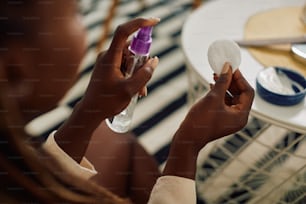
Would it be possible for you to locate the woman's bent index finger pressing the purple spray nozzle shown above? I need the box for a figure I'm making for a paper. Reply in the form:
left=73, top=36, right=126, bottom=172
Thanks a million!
left=109, top=18, right=160, bottom=58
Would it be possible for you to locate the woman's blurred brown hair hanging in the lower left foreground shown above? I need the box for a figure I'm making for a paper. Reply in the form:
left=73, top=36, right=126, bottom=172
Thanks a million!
left=0, top=83, right=127, bottom=204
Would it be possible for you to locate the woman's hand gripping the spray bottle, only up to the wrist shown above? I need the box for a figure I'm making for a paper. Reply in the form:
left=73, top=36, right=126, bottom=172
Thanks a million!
left=82, top=18, right=159, bottom=119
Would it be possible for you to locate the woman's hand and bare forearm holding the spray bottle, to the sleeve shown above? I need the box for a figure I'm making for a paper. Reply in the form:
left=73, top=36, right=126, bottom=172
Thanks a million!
left=55, top=18, right=159, bottom=162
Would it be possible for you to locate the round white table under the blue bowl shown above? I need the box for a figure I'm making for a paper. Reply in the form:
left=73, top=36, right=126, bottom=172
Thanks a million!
left=181, top=0, right=306, bottom=134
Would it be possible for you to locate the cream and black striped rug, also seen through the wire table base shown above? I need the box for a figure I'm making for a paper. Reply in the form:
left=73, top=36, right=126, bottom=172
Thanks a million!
left=26, top=0, right=306, bottom=204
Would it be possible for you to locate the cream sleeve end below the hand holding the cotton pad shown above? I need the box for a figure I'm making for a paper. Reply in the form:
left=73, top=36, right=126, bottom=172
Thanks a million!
left=148, top=176, right=196, bottom=204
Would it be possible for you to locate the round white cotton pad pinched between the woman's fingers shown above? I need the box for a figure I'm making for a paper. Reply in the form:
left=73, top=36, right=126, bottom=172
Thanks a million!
left=207, top=40, right=241, bottom=75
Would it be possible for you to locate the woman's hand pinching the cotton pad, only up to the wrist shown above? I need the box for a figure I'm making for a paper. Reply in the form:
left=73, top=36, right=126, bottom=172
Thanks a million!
left=181, top=63, right=254, bottom=149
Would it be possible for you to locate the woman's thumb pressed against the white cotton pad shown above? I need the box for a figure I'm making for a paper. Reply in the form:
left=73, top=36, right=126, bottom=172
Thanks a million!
left=214, top=62, right=232, bottom=94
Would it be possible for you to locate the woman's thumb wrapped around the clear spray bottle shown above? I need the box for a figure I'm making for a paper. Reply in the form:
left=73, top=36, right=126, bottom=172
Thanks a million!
left=126, top=57, right=159, bottom=96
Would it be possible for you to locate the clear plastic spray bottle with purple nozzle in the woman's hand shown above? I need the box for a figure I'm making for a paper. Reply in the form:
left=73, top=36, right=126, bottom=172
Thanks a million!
left=106, top=27, right=153, bottom=133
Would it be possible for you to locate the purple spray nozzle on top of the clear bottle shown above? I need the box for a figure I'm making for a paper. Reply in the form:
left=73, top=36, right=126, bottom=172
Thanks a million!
left=130, top=26, right=153, bottom=55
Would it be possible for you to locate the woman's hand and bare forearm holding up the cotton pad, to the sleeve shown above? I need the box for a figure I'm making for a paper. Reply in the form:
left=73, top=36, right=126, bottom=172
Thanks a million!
left=164, top=63, right=254, bottom=179
